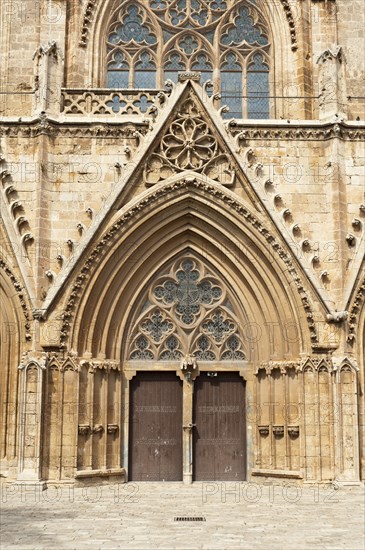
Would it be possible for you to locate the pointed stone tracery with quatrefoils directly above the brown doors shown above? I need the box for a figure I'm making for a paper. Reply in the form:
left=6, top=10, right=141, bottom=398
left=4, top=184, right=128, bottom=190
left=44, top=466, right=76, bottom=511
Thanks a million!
left=128, top=257, right=245, bottom=361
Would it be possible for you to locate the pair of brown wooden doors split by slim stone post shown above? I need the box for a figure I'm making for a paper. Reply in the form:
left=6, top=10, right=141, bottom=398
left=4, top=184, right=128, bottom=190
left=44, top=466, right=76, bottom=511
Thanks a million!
left=128, top=371, right=246, bottom=481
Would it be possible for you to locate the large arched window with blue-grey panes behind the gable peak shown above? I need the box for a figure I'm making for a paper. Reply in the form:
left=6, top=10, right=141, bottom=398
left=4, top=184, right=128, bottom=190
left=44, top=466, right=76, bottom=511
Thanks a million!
left=106, top=0, right=272, bottom=118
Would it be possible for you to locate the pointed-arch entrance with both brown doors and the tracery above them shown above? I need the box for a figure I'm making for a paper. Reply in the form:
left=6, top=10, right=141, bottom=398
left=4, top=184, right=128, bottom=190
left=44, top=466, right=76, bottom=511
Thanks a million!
left=123, top=253, right=247, bottom=482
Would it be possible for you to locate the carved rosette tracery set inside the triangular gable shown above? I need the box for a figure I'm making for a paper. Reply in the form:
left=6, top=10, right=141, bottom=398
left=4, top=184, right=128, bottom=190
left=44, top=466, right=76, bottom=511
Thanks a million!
left=143, top=97, right=235, bottom=186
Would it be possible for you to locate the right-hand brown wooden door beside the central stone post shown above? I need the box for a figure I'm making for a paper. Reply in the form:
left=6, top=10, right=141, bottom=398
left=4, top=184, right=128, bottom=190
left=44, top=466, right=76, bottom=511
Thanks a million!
left=194, top=372, right=246, bottom=481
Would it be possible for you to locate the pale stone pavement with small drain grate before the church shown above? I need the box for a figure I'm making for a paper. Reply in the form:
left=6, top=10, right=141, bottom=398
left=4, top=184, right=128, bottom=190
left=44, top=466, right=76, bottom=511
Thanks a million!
left=0, top=481, right=365, bottom=550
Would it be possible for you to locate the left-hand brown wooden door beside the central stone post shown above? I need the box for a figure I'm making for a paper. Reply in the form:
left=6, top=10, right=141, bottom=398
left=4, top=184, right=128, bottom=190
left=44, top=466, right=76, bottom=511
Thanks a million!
left=129, top=372, right=182, bottom=481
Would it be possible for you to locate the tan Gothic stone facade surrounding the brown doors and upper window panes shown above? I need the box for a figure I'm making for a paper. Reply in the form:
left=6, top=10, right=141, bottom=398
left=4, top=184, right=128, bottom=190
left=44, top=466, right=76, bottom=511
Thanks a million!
left=0, top=0, right=365, bottom=482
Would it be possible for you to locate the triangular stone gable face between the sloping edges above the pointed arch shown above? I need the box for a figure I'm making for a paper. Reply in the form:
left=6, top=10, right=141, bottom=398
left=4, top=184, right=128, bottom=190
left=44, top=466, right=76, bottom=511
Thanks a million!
left=118, top=81, right=261, bottom=210
